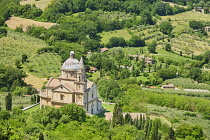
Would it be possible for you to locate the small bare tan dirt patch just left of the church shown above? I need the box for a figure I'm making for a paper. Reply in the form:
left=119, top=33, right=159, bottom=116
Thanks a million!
left=24, top=73, right=47, bottom=89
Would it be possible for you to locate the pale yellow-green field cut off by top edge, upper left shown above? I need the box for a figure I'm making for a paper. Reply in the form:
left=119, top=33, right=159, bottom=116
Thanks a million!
left=20, top=0, right=52, bottom=10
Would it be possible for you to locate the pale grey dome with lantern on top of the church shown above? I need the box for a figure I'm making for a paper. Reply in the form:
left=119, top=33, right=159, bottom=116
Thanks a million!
left=61, top=51, right=79, bottom=70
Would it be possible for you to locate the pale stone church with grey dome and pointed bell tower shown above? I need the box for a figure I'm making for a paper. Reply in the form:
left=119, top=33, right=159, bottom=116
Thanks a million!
left=40, top=51, right=102, bottom=114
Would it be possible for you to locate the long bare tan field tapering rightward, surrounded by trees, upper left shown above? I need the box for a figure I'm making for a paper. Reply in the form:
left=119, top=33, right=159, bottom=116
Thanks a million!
left=5, top=16, right=56, bottom=31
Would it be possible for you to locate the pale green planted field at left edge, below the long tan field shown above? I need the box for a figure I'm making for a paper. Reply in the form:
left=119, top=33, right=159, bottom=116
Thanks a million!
left=0, top=30, right=48, bottom=65
